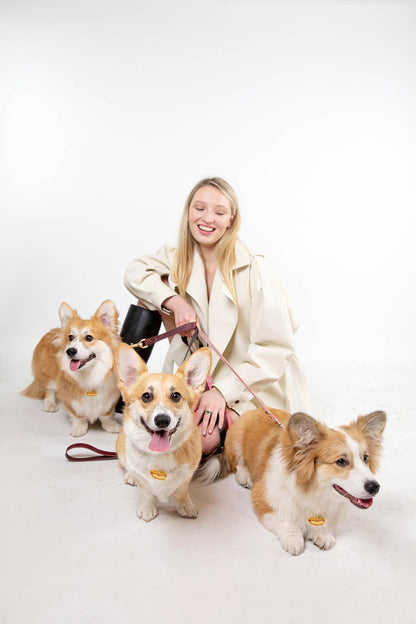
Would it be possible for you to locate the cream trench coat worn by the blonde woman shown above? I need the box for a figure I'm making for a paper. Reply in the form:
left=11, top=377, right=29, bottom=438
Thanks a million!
left=124, top=242, right=311, bottom=413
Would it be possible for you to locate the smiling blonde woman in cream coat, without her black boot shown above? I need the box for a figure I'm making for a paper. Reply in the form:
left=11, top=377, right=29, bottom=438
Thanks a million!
left=124, top=178, right=309, bottom=454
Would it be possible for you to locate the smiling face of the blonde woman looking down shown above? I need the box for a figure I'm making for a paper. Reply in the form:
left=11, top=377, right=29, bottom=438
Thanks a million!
left=188, top=186, right=234, bottom=248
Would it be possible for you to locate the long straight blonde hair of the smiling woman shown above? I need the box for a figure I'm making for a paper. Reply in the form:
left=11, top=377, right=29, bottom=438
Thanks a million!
left=172, top=178, right=241, bottom=305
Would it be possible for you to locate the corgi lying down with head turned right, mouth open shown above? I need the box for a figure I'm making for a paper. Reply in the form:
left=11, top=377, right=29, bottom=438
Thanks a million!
left=225, top=409, right=386, bottom=555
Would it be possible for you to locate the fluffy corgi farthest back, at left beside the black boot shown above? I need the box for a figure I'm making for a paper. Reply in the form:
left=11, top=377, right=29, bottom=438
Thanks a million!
left=22, top=299, right=121, bottom=436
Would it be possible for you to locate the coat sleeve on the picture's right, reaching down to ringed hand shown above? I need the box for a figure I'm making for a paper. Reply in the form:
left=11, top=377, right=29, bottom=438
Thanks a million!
left=214, top=256, right=297, bottom=409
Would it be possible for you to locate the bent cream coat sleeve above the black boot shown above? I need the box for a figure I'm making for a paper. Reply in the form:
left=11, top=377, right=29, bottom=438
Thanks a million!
left=124, top=245, right=177, bottom=310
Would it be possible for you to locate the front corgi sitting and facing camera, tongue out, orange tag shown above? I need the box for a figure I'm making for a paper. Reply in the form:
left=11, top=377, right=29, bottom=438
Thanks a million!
left=115, top=343, right=211, bottom=522
